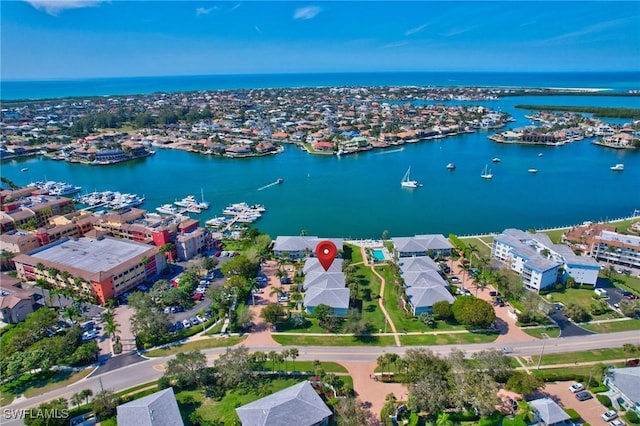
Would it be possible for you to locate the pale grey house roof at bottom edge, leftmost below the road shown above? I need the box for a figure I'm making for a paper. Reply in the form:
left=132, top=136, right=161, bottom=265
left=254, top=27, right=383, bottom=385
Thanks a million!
left=117, top=388, right=184, bottom=426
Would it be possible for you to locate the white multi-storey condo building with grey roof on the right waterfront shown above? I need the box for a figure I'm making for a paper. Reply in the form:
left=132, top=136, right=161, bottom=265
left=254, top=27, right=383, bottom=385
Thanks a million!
left=491, top=229, right=600, bottom=291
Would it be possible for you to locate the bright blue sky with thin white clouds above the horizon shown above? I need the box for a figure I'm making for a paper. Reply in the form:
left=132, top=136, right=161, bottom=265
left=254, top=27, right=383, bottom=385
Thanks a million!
left=0, top=0, right=640, bottom=80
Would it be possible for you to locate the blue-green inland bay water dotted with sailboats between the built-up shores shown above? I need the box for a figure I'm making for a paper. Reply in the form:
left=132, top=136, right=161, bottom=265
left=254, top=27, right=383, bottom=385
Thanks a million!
left=2, top=96, right=640, bottom=238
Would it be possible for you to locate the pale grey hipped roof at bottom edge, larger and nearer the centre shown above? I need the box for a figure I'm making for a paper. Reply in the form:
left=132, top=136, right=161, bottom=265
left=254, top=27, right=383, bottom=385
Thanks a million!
left=238, top=381, right=332, bottom=426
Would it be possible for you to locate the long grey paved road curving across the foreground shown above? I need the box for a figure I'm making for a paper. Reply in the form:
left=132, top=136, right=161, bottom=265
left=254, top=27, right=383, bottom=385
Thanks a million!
left=2, top=331, right=640, bottom=426
